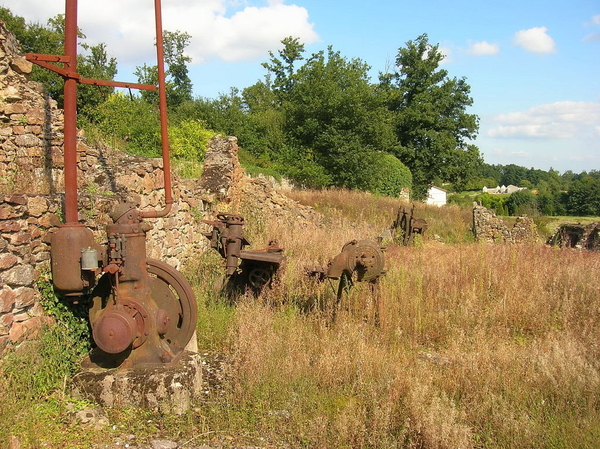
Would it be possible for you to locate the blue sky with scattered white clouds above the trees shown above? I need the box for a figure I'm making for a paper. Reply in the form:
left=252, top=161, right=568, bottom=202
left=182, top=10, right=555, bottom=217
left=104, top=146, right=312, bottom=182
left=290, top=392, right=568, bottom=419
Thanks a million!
left=0, top=0, right=600, bottom=173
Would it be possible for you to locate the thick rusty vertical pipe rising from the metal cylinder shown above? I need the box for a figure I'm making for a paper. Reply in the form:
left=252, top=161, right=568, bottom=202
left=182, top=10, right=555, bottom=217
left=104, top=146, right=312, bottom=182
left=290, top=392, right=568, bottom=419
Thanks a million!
left=64, top=0, right=78, bottom=224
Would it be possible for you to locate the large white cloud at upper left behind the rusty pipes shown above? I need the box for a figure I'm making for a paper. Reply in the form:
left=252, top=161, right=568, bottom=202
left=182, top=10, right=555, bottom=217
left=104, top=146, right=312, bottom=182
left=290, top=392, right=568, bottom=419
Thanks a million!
left=3, top=0, right=318, bottom=65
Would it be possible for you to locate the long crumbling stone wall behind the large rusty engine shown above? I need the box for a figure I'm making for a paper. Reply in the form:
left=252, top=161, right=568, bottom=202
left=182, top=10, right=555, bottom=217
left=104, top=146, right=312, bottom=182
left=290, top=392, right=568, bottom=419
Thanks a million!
left=0, top=21, right=319, bottom=357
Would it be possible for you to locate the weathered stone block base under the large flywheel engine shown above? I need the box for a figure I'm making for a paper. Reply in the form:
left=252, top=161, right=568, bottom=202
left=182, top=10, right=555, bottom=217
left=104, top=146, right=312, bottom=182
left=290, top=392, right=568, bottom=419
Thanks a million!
left=71, top=351, right=202, bottom=415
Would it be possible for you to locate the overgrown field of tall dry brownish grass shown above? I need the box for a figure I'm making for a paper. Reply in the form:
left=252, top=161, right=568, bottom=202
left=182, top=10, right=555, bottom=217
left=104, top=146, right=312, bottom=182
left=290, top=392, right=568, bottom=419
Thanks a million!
left=0, top=191, right=600, bottom=448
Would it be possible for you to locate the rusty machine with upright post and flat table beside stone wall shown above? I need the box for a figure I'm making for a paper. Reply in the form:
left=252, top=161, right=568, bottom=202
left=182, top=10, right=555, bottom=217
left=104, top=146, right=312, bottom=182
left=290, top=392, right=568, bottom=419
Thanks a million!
left=202, top=213, right=285, bottom=294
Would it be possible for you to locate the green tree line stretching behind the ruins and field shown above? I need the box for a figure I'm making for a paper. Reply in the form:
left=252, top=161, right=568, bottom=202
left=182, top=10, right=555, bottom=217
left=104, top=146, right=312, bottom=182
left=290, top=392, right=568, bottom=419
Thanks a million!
left=0, top=7, right=600, bottom=215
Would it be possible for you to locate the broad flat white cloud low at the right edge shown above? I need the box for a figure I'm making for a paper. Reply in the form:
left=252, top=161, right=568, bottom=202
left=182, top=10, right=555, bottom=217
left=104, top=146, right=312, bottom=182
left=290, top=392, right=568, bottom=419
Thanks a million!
left=487, top=101, right=600, bottom=139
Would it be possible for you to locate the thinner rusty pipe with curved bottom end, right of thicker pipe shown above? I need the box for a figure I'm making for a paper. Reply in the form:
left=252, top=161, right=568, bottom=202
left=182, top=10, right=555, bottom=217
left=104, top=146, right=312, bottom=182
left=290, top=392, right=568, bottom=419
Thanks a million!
left=140, top=0, right=173, bottom=218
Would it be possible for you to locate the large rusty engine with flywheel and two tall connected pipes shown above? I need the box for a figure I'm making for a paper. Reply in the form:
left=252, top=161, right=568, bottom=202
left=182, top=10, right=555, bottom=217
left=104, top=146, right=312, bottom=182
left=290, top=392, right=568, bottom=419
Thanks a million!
left=27, top=0, right=197, bottom=368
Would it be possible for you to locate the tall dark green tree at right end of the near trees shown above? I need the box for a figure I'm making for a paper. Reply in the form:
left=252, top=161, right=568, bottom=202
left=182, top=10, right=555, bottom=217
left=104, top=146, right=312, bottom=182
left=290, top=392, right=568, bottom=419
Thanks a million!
left=380, top=34, right=481, bottom=196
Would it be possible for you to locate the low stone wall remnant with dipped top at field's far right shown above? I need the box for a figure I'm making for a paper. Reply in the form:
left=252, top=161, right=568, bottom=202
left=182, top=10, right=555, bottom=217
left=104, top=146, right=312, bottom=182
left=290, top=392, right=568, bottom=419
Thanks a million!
left=473, top=204, right=540, bottom=243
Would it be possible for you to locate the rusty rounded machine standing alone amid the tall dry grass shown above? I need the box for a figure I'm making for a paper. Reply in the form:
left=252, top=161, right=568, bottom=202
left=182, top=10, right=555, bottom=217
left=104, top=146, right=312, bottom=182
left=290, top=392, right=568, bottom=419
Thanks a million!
left=306, top=240, right=385, bottom=301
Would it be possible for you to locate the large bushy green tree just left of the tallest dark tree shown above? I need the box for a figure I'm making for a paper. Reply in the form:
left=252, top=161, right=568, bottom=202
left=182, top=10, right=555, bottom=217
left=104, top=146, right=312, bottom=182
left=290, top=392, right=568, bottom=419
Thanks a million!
left=258, top=38, right=404, bottom=190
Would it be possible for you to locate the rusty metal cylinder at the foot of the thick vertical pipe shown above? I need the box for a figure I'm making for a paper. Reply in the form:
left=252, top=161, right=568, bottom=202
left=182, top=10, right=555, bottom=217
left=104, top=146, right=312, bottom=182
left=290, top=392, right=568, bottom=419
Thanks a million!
left=50, top=224, right=94, bottom=296
